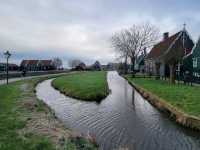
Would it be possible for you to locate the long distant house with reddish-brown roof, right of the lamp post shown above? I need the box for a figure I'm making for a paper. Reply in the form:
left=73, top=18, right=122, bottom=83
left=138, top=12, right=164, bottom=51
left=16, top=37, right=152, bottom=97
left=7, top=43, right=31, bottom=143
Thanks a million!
left=20, top=60, right=55, bottom=71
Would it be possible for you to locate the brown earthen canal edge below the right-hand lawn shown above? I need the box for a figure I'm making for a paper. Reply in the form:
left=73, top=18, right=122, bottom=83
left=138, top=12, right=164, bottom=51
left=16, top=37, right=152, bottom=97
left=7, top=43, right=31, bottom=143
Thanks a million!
left=124, top=77, right=200, bottom=131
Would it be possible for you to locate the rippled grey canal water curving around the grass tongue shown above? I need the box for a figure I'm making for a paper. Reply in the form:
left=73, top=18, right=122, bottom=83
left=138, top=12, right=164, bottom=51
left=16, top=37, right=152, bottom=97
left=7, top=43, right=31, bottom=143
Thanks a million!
left=36, top=72, right=200, bottom=150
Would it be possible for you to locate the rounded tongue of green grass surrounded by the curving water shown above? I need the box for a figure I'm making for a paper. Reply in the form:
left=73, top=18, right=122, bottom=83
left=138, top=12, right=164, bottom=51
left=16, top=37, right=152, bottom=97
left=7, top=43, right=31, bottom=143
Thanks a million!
left=52, top=71, right=109, bottom=101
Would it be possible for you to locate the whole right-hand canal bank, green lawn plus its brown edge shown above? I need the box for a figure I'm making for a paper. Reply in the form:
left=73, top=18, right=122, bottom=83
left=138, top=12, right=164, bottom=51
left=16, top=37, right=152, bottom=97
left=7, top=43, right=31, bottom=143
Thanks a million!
left=125, top=75, right=200, bottom=130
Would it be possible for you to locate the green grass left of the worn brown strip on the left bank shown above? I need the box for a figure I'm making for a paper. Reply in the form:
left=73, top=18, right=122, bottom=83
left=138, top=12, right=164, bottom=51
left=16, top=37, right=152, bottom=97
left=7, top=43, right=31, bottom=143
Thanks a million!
left=0, top=82, right=53, bottom=150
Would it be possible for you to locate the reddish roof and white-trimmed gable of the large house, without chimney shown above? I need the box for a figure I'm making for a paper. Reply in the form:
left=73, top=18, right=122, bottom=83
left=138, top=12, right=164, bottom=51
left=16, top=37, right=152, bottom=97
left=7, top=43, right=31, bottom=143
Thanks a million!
left=147, top=30, right=194, bottom=62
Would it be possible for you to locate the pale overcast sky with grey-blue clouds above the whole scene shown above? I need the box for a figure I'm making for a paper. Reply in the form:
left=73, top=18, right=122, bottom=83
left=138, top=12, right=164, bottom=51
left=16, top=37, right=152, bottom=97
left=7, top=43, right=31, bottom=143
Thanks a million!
left=0, top=0, right=200, bottom=66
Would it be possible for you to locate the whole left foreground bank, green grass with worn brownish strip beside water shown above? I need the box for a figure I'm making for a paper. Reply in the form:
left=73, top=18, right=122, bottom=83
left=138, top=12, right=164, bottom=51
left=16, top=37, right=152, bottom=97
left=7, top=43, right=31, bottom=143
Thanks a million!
left=0, top=75, right=97, bottom=150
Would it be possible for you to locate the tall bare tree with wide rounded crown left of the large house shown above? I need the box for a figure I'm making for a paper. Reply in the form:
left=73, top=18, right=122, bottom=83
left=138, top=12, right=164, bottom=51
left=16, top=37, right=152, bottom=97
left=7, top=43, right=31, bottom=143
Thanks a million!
left=112, top=23, right=159, bottom=75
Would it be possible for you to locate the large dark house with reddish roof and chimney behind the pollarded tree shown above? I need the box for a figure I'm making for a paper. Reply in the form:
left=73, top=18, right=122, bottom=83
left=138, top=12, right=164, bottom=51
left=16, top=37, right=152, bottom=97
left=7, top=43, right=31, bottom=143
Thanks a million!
left=145, top=28, right=194, bottom=77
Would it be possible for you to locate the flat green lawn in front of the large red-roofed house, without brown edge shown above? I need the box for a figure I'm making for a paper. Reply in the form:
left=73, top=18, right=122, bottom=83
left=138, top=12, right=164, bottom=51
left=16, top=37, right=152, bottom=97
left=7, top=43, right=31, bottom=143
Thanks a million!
left=126, top=75, right=200, bottom=117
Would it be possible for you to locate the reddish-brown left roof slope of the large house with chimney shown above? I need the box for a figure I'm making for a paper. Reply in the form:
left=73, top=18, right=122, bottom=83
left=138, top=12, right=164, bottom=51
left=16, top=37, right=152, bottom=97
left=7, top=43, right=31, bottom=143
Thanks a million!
left=146, top=31, right=181, bottom=59
